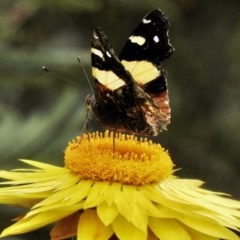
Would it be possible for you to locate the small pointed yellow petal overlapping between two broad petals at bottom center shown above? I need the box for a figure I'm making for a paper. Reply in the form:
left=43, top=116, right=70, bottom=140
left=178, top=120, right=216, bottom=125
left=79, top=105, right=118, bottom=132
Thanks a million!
left=97, top=202, right=119, bottom=226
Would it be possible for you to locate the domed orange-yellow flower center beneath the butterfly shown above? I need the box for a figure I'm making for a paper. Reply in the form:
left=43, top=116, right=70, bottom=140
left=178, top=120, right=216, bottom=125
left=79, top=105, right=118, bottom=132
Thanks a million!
left=65, top=131, right=173, bottom=186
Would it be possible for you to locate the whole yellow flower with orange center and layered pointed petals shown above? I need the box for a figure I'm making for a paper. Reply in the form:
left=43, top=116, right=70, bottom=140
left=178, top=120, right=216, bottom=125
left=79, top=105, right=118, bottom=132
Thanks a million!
left=0, top=132, right=240, bottom=240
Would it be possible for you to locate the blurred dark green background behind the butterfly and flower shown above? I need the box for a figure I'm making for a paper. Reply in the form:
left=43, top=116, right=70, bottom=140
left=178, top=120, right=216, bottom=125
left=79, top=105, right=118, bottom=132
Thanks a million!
left=0, top=0, right=240, bottom=240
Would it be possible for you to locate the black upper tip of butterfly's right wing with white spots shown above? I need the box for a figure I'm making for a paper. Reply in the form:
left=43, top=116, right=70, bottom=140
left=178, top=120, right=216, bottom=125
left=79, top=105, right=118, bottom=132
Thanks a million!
left=119, top=9, right=174, bottom=65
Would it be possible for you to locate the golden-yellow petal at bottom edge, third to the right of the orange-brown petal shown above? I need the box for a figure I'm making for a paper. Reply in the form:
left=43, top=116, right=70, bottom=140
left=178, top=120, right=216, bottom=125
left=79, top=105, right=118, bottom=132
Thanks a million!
left=148, top=217, right=191, bottom=240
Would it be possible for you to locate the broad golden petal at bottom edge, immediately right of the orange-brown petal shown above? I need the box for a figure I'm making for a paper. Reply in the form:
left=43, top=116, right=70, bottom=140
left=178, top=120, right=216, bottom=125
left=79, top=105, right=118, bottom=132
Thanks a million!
left=77, top=209, right=113, bottom=240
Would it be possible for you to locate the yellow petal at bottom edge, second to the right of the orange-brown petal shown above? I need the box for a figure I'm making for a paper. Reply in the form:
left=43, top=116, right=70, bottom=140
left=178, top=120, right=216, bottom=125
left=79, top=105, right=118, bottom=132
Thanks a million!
left=113, top=215, right=147, bottom=240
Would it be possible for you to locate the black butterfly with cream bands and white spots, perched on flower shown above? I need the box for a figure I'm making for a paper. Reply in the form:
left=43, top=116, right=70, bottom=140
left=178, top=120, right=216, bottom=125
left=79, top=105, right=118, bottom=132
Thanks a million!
left=85, top=9, right=174, bottom=136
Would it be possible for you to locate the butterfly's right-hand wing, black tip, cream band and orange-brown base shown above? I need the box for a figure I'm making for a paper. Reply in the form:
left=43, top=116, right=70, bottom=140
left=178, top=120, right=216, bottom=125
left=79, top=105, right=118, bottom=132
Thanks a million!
left=119, top=9, right=174, bottom=122
